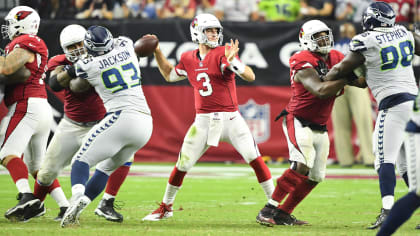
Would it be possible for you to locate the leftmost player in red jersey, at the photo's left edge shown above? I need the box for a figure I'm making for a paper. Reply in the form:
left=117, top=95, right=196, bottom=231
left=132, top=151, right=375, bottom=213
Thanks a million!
left=0, top=6, right=53, bottom=221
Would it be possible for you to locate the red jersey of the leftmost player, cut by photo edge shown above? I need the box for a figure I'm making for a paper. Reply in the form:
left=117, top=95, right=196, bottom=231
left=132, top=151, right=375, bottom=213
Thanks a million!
left=4, top=34, right=48, bottom=106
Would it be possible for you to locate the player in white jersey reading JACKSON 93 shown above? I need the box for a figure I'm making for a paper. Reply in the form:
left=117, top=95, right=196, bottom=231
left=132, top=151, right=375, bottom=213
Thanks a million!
left=57, top=25, right=153, bottom=227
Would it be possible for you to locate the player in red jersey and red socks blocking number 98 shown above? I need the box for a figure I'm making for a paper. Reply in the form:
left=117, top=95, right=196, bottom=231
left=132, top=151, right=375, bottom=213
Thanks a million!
left=257, top=20, right=362, bottom=225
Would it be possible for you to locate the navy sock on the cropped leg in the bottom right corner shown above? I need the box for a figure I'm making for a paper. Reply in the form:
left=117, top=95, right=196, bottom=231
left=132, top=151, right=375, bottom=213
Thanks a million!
left=377, top=192, right=420, bottom=236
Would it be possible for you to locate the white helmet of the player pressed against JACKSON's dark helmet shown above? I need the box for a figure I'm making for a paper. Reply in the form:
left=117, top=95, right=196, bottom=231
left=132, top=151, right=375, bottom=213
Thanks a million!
left=60, top=24, right=87, bottom=62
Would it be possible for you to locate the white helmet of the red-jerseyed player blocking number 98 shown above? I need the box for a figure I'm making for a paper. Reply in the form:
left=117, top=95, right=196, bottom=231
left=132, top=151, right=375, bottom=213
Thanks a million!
left=299, top=20, right=334, bottom=54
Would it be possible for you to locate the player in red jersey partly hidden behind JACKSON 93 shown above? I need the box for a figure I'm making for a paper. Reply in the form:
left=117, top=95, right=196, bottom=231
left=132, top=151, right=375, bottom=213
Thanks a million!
left=27, top=24, right=132, bottom=222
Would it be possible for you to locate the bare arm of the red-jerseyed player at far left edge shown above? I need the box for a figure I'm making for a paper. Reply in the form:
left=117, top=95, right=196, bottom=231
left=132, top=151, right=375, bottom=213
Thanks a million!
left=0, top=48, right=35, bottom=75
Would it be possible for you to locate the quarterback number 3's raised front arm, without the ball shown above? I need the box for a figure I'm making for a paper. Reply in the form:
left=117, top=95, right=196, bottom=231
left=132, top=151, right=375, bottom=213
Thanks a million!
left=225, top=39, right=255, bottom=82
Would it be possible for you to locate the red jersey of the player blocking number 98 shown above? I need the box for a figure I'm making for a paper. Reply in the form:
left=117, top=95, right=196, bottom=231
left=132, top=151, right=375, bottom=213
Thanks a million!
left=286, top=50, right=344, bottom=125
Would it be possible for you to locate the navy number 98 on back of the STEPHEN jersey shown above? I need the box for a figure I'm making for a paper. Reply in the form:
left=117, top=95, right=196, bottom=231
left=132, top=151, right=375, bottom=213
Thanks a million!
left=381, top=41, right=414, bottom=70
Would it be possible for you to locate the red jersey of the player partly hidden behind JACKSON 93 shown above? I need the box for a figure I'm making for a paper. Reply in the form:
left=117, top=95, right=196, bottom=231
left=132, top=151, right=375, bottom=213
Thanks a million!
left=48, top=54, right=106, bottom=122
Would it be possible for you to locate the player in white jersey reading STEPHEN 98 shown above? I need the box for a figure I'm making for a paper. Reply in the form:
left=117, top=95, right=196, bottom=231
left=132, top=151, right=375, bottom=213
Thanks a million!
left=326, top=2, right=420, bottom=229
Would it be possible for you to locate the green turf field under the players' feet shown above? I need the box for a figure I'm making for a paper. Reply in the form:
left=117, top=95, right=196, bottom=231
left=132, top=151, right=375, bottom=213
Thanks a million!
left=0, top=165, right=420, bottom=236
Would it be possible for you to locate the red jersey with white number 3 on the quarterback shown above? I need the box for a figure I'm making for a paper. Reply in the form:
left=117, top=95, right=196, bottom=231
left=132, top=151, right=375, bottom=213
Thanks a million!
left=175, top=46, right=238, bottom=113
